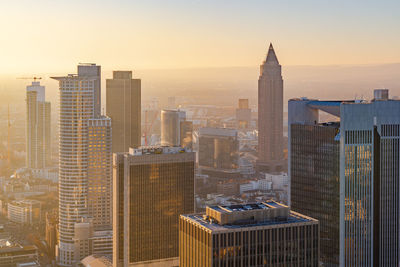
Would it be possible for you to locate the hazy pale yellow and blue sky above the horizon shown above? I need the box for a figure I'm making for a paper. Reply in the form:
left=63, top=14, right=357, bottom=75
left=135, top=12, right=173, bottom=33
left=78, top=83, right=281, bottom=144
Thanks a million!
left=0, top=0, right=400, bottom=74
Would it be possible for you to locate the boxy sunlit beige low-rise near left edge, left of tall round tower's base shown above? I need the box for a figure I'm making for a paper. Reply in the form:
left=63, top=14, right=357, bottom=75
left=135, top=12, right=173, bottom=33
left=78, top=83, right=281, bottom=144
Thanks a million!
left=7, top=200, right=41, bottom=225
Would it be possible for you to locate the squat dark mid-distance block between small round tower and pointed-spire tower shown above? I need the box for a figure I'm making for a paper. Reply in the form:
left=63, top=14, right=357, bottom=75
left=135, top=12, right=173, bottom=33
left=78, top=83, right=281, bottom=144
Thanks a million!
left=198, top=128, right=239, bottom=174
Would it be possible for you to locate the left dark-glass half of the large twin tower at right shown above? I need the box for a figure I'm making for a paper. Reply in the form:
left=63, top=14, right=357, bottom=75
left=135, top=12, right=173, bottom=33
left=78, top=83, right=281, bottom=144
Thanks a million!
left=288, top=98, right=342, bottom=266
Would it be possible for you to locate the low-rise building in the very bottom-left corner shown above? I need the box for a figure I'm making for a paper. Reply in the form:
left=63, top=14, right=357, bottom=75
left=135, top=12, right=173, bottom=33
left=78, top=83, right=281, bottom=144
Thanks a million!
left=0, top=245, right=39, bottom=267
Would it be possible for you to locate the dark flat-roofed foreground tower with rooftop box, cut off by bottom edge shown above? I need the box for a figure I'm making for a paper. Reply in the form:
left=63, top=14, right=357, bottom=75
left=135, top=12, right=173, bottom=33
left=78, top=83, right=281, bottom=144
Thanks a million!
left=179, top=201, right=319, bottom=267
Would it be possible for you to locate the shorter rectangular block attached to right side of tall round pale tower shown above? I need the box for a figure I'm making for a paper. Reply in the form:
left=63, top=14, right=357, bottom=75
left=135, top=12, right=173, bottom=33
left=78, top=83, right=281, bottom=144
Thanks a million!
left=87, top=116, right=112, bottom=230
